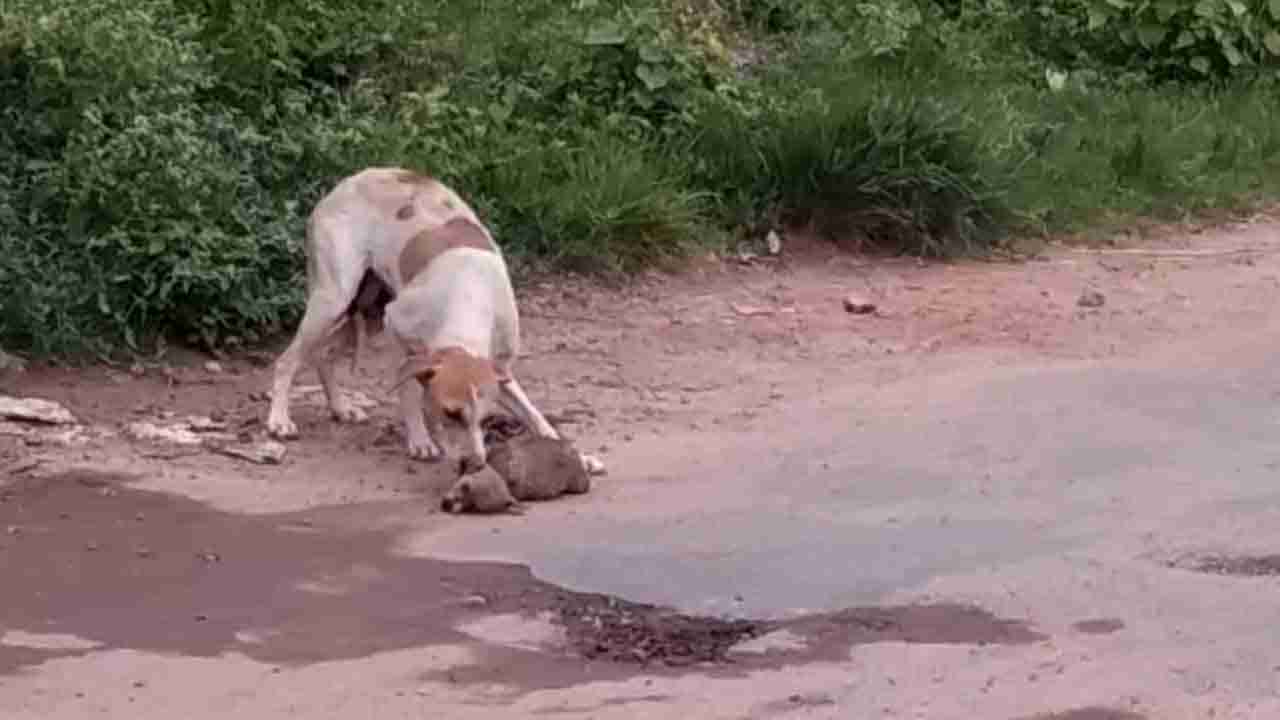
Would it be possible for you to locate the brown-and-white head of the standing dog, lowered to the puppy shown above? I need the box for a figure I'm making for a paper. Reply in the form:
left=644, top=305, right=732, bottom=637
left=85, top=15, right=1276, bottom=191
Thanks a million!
left=396, top=347, right=504, bottom=475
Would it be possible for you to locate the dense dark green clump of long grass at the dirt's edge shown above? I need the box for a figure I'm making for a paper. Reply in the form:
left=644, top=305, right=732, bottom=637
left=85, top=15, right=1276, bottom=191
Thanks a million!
left=696, top=76, right=1006, bottom=256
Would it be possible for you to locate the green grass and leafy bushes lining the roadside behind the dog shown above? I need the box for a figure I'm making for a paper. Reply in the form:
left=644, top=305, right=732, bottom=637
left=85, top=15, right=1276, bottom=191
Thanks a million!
left=0, top=0, right=1280, bottom=355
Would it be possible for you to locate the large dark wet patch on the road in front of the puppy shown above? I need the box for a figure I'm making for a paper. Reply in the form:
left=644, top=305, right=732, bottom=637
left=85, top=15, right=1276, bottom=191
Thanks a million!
left=0, top=471, right=1043, bottom=688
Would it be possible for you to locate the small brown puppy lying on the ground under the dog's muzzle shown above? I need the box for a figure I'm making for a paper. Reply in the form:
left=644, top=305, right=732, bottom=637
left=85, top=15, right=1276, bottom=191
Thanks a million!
left=440, top=419, right=593, bottom=514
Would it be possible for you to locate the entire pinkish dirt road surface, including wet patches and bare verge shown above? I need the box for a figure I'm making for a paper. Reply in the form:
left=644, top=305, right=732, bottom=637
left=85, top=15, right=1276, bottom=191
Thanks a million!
left=0, top=219, right=1280, bottom=720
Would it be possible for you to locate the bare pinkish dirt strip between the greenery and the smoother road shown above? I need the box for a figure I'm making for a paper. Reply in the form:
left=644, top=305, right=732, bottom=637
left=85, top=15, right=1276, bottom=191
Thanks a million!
left=0, top=210, right=1280, bottom=512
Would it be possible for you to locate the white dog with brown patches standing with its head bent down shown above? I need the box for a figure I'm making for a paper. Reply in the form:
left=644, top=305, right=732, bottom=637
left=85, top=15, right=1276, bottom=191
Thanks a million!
left=268, top=168, right=559, bottom=475
